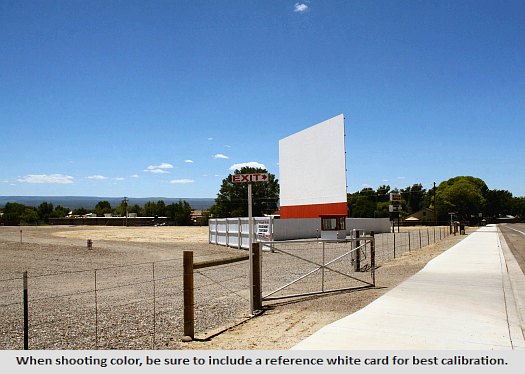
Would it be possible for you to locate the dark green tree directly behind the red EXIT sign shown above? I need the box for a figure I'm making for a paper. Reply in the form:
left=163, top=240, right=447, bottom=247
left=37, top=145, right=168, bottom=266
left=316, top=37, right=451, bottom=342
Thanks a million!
left=210, top=166, right=279, bottom=218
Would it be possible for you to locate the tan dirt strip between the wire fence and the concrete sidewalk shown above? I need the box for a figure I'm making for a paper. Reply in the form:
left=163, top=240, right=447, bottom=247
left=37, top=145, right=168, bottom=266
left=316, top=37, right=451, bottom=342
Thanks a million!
left=186, top=231, right=469, bottom=350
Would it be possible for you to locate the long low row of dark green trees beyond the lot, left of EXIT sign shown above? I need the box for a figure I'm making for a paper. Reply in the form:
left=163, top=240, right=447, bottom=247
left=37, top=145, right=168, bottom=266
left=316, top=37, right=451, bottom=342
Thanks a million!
left=0, top=200, right=193, bottom=226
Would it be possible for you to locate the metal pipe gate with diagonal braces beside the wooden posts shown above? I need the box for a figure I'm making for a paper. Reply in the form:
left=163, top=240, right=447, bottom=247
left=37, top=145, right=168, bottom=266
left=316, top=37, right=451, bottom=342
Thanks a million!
left=261, top=235, right=375, bottom=302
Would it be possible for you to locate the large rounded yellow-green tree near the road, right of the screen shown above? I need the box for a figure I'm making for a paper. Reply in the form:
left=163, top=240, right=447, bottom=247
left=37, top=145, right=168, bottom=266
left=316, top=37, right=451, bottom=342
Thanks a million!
left=436, top=176, right=488, bottom=222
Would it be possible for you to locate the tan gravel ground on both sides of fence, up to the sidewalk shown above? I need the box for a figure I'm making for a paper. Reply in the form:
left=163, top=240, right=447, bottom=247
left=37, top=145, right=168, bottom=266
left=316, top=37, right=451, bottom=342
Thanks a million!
left=0, top=226, right=463, bottom=349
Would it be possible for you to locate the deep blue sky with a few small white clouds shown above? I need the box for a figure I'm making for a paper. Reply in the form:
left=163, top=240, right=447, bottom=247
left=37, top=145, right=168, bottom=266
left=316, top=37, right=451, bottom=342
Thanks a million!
left=0, top=0, right=525, bottom=197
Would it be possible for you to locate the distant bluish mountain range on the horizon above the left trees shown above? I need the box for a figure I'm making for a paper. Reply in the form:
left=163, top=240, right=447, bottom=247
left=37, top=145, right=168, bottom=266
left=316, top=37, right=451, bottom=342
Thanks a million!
left=0, top=196, right=215, bottom=210
